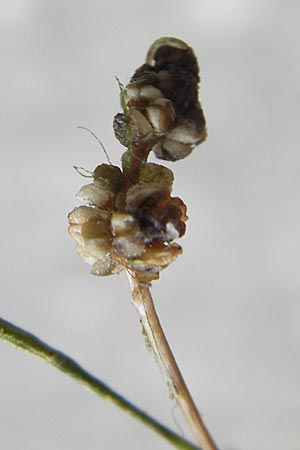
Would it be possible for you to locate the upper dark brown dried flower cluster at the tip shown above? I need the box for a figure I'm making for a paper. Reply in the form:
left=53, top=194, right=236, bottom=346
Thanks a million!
left=114, top=38, right=207, bottom=161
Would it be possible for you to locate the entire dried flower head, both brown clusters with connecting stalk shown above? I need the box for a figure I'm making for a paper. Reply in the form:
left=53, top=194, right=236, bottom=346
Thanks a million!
left=68, top=38, right=206, bottom=283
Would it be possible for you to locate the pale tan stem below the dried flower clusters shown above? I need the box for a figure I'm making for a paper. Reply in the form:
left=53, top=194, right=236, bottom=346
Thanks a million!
left=129, top=275, right=217, bottom=450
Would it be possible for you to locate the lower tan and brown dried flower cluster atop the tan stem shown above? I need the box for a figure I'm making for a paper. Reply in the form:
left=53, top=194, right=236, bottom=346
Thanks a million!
left=68, top=163, right=187, bottom=282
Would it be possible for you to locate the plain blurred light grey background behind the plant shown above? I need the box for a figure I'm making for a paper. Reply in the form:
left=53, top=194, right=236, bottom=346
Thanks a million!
left=0, top=0, right=300, bottom=450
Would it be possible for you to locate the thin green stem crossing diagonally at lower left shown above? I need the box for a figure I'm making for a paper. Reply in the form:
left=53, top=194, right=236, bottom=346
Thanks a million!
left=0, top=317, right=201, bottom=450
